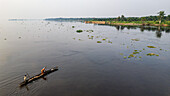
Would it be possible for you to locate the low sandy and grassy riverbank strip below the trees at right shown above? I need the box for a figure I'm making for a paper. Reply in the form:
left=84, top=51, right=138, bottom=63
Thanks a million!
left=85, top=21, right=170, bottom=27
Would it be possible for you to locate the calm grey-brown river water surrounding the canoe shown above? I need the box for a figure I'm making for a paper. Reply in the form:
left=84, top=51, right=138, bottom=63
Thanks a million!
left=0, top=20, right=170, bottom=96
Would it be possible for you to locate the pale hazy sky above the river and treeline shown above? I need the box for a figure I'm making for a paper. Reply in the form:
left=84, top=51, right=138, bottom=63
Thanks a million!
left=0, top=0, right=170, bottom=19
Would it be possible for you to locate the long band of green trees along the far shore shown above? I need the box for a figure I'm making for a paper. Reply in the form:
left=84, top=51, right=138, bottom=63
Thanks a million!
left=45, top=11, right=170, bottom=23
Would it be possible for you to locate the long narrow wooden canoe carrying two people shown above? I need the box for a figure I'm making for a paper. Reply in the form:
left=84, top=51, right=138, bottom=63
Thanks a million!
left=19, top=67, right=58, bottom=87
